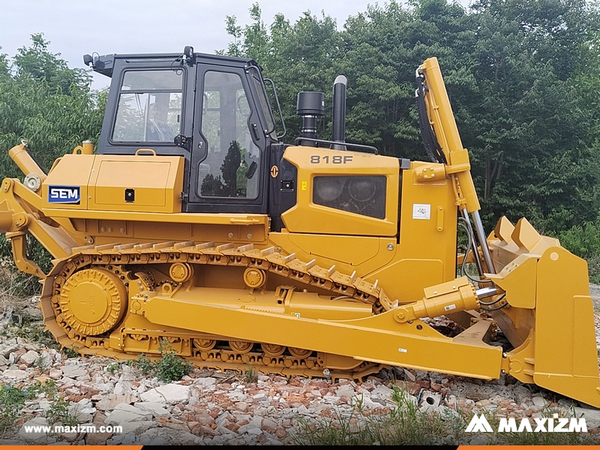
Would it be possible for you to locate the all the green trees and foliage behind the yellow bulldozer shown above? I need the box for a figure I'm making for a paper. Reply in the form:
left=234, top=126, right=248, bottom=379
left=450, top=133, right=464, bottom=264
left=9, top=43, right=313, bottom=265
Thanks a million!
left=0, top=0, right=600, bottom=286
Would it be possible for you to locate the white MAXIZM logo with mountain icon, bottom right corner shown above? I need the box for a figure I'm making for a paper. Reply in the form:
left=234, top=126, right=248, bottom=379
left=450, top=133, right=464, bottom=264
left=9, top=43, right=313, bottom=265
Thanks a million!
left=465, top=414, right=587, bottom=433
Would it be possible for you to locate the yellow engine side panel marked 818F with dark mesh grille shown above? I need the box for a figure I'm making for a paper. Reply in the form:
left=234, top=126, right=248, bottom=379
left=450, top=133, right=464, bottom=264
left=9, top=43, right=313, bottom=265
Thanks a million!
left=281, top=147, right=400, bottom=236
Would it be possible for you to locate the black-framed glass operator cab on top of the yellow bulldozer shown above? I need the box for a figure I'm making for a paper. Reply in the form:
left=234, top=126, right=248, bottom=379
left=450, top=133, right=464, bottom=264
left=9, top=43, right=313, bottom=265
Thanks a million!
left=84, top=47, right=283, bottom=214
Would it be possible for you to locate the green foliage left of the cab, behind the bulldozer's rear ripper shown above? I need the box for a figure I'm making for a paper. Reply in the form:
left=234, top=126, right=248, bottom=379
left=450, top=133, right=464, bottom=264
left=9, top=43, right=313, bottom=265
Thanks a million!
left=0, top=34, right=107, bottom=294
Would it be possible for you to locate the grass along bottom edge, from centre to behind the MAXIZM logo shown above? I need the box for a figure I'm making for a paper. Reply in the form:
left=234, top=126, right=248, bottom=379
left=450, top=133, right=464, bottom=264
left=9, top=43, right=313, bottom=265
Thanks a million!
left=292, top=386, right=600, bottom=446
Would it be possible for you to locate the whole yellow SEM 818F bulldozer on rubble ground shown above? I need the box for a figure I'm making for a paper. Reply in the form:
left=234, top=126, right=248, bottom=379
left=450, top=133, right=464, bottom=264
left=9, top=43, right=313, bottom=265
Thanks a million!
left=0, top=46, right=600, bottom=407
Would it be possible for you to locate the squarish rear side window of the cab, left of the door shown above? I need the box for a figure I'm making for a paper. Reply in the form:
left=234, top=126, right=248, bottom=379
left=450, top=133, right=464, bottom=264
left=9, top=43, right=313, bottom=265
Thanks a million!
left=112, top=70, right=183, bottom=144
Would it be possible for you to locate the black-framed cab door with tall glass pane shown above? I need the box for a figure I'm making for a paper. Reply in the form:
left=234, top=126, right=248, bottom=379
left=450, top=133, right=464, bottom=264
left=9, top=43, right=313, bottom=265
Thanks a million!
left=186, top=61, right=267, bottom=213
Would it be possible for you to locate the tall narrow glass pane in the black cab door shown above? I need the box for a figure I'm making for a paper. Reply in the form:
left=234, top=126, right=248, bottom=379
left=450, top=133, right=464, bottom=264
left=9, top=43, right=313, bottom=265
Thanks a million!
left=197, top=71, right=260, bottom=199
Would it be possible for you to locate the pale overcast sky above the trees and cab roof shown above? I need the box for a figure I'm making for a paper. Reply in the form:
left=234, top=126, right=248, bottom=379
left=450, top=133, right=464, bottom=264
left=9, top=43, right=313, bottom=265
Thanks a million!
left=0, top=0, right=466, bottom=89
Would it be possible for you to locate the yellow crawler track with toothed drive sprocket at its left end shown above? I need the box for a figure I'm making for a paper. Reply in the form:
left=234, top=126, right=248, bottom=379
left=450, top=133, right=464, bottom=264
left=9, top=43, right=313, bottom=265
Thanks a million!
left=40, top=241, right=393, bottom=379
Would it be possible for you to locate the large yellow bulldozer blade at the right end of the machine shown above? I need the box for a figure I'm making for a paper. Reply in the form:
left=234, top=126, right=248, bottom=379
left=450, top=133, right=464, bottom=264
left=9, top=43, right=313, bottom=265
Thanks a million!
left=489, top=246, right=600, bottom=407
